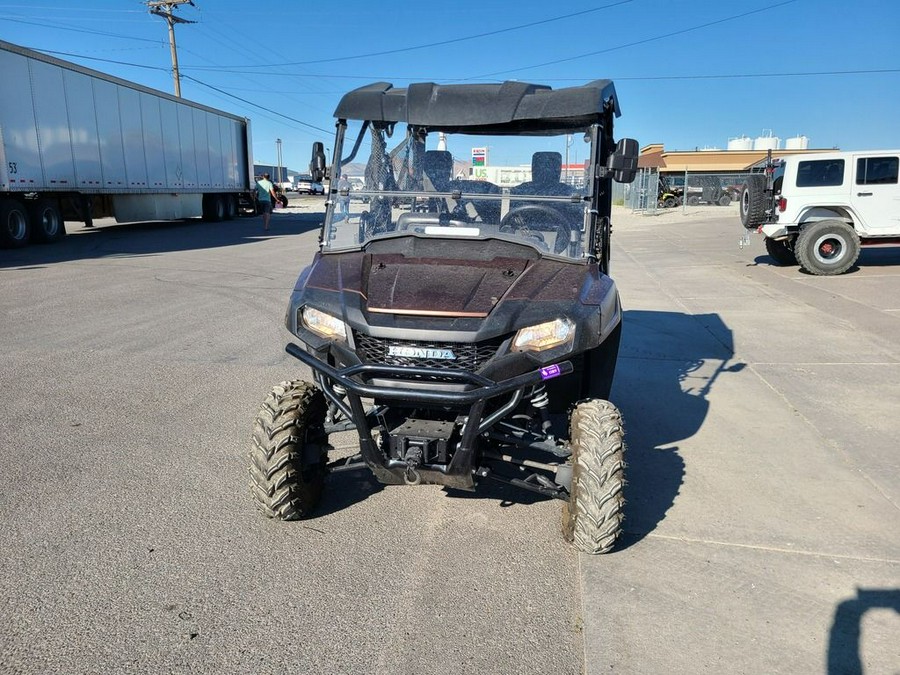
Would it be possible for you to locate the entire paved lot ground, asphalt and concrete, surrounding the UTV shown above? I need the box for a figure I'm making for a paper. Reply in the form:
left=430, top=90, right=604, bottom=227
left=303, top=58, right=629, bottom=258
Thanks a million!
left=0, top=197, right=900, bottom=674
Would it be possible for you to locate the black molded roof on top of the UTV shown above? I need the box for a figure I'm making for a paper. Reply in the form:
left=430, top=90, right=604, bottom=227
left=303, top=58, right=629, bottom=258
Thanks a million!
left=334, top=80, right=621, bottom=134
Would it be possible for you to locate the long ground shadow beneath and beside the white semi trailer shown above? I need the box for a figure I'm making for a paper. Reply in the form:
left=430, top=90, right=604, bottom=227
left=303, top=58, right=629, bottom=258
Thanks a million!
left=0, top=210, right=324, bottom=269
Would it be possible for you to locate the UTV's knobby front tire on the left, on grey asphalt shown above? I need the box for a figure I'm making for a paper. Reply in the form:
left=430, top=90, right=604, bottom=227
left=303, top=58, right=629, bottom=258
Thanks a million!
left=250, top=380, right=329, bottom=520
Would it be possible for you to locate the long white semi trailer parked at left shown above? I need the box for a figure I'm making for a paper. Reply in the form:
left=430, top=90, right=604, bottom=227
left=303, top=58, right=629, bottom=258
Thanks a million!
left=0, top=40, right=254, bottom=247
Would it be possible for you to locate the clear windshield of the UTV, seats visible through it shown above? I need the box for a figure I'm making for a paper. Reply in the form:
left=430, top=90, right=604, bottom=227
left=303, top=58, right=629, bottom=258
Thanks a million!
left=322, top=121, right=592, bottom=259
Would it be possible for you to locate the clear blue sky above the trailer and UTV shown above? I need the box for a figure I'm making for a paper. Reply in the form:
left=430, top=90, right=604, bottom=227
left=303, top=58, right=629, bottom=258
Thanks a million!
left=0, top=0, right=900, bottom=170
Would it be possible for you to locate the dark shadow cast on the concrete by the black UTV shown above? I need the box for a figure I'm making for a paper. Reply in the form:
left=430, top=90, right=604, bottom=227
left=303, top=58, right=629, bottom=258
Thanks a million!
left=611, top=310, right=745, bottom=550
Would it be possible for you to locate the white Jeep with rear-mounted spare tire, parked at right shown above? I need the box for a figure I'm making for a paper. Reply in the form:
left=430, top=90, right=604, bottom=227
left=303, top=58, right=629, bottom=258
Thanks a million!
left=740, top=150, right=900, bottom=275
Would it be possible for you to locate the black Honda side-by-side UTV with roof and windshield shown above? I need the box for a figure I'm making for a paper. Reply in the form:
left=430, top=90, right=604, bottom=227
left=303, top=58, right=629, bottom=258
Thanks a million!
left=250, top=80, right=638, bottom=553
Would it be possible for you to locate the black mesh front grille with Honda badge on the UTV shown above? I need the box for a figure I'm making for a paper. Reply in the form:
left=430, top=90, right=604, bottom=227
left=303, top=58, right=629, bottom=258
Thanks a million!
left=354, top=333, right=502, bottom=373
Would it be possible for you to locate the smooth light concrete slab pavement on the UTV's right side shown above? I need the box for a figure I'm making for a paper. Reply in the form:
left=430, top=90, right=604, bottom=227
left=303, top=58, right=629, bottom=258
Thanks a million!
left=579, top=207, right=900, bottom=675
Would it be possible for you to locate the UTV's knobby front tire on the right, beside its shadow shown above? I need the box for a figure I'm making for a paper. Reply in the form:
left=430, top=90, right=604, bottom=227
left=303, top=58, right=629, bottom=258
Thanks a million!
left=562, top=399, right=625, bottom=555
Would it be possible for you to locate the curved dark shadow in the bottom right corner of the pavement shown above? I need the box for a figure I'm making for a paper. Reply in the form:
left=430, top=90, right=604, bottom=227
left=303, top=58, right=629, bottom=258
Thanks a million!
left=828, top=588, right=900, bottom=675
